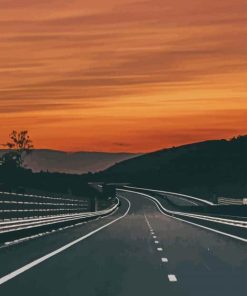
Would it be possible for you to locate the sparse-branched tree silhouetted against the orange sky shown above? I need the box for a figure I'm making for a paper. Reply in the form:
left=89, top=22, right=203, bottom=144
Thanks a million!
left=2, top=131, right=33, bottom=168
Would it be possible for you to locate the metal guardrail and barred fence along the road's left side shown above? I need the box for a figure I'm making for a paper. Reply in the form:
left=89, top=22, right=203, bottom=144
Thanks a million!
left=0, top=192, right=119, bottom=243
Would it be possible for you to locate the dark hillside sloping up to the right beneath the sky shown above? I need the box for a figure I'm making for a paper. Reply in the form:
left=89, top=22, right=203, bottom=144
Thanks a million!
left=95, top=136, right=247, bottom=198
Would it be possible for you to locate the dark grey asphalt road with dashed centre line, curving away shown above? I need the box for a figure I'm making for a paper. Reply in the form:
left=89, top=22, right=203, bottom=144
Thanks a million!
left=0, top=192, right=247, bottom=296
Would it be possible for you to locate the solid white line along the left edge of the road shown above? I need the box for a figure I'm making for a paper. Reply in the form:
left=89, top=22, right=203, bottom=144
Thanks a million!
left=0, top=197, right=131, bottom=285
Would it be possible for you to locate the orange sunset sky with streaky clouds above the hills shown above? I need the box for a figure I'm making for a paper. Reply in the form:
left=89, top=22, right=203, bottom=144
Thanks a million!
left=0, top=0, right=247, bottom=152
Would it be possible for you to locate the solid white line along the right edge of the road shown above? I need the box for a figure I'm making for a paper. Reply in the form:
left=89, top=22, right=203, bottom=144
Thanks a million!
left=118, top=189, right=247, bottom=243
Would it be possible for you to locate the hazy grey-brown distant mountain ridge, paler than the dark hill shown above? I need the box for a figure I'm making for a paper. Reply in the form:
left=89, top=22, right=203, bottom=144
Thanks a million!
left=0, top=149, right=138, bottom=174
